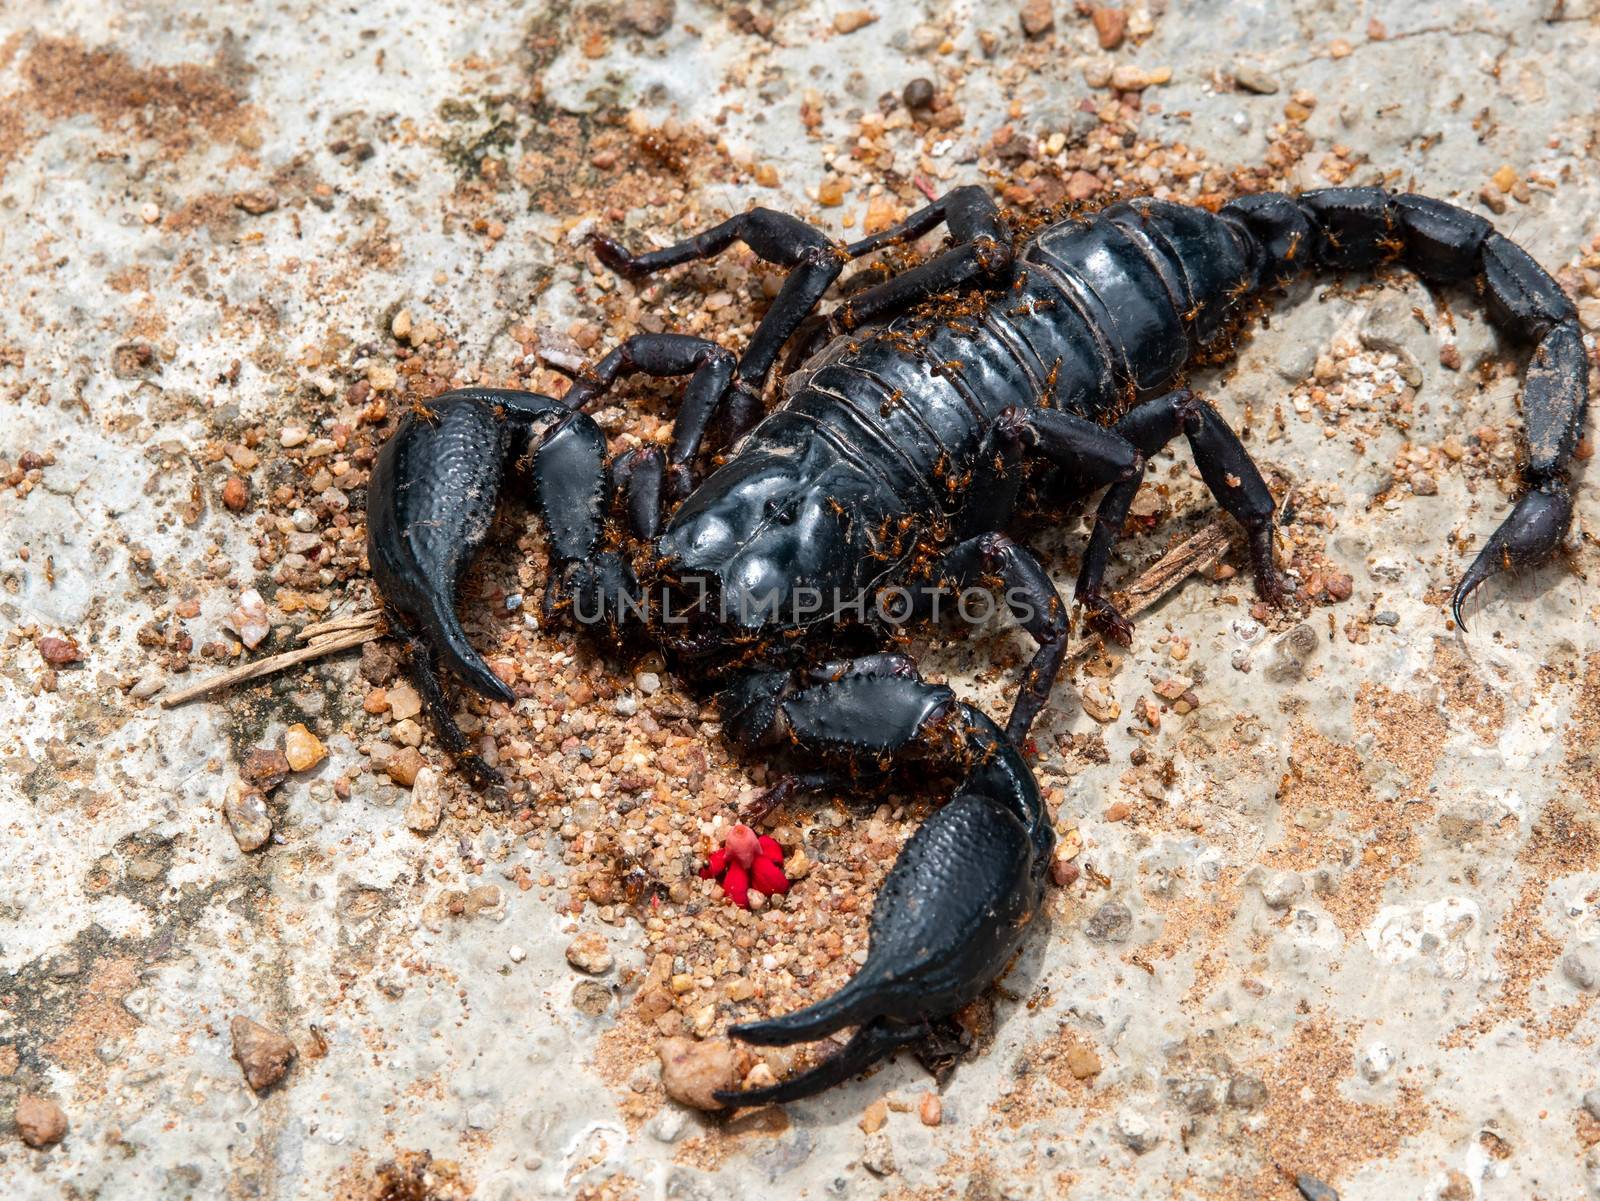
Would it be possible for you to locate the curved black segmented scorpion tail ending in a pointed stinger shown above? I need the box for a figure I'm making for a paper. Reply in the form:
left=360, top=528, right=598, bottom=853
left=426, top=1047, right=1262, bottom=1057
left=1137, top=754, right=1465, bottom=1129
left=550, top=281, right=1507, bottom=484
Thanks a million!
left=1221, top=187, right=1589, bottom=630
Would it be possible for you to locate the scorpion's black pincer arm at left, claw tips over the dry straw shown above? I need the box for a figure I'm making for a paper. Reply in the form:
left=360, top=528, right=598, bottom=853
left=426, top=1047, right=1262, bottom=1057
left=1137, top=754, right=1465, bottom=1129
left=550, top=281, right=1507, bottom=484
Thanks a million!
left=366, top=389, right=630, bottom=782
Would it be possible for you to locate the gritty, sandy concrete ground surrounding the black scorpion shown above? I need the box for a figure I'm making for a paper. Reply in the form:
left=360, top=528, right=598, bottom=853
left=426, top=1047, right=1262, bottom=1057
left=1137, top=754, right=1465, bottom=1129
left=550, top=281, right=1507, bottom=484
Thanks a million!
left=0, top=0, right=1600, bottom=1201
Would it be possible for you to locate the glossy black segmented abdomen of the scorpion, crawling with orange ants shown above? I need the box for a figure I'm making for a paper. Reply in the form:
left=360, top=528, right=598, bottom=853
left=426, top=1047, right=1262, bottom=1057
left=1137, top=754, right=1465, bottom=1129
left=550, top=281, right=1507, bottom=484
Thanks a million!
left=752, top=200, right=1251, bottom=524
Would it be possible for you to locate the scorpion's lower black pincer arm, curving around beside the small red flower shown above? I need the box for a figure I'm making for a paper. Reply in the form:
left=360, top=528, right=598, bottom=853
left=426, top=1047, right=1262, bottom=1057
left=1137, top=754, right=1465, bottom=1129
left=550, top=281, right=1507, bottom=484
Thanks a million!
left=717, top=656, right=1054, bottom=1105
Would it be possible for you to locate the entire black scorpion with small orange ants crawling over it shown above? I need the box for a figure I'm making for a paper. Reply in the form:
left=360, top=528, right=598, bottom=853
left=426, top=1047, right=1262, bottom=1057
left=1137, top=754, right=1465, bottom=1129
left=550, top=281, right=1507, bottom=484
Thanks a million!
left=368, top=187, right=1587, bottom=1103
